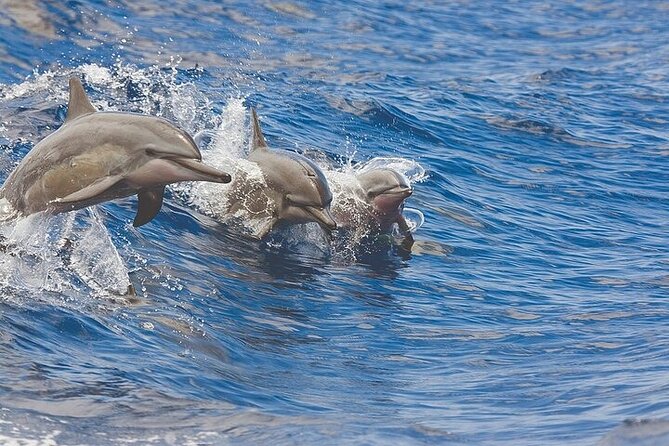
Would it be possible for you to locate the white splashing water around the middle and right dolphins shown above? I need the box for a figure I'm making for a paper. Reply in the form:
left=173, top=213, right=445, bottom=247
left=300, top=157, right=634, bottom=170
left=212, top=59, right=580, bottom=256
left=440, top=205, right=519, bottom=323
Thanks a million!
left=177, top=98, right=427, bottom=254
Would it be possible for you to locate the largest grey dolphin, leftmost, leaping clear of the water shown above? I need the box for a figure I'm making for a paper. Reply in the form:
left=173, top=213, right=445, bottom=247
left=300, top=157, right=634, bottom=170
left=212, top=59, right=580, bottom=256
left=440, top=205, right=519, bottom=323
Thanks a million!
left=0, top=78, right=231, bottom=226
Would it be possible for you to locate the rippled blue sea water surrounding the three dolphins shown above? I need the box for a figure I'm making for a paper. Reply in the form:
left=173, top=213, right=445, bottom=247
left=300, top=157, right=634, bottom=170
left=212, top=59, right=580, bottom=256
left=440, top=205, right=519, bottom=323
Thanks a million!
left=0, top=0, right=669, bottom=445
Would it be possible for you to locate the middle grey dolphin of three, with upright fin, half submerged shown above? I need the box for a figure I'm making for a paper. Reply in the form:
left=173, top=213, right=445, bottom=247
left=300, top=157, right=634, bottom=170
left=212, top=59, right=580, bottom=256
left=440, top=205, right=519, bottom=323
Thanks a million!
left=228, top=109, right=337, bottom=239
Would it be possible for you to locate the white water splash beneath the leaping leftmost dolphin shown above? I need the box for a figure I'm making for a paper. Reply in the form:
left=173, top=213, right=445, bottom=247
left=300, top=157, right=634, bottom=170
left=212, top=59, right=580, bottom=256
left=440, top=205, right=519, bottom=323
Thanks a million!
left=0, top=208, right=130, bottom=303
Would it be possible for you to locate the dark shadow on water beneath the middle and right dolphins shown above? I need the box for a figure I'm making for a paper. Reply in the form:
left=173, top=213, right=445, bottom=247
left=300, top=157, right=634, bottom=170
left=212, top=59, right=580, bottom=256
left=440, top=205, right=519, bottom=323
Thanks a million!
left=188, top=204, right=410, bottom=287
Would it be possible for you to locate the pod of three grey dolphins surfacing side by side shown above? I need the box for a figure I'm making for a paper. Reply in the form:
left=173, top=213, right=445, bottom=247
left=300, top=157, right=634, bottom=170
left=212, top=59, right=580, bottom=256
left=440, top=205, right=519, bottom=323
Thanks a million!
left=0, top=77, right=413, bottom=242
